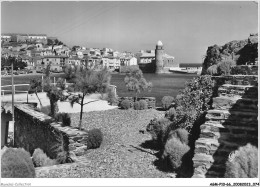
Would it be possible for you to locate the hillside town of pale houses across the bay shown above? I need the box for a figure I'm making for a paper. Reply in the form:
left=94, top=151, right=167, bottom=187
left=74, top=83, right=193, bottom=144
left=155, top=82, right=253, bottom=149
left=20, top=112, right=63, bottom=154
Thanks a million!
left=1, top=33, right=185, bottom=75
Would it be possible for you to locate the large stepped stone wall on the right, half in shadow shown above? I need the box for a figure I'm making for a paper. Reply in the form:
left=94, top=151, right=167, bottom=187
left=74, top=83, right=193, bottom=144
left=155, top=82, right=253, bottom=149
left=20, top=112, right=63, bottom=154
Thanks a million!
left=193, top=75, right=258, bottom=178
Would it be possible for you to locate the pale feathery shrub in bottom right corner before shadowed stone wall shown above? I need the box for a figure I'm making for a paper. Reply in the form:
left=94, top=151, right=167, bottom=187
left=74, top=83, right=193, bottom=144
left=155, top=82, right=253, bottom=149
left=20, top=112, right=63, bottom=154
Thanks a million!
left=225, top=144, right=258, bottom=178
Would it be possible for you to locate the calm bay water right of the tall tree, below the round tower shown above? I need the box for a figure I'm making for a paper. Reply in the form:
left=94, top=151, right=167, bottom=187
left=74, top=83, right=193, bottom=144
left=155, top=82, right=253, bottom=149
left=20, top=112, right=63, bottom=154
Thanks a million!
left=111, top=74, right=197, bottom=106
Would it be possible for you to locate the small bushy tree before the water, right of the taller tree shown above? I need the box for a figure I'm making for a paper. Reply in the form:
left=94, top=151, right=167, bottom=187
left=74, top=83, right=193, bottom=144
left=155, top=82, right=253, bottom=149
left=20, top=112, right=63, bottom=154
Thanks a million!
left=125, top=66, right=152, bottom=101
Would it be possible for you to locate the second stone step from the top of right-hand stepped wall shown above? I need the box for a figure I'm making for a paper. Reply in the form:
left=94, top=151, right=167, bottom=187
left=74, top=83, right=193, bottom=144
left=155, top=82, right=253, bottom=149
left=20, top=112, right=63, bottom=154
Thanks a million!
left=218, top=84, right=258, bottom=98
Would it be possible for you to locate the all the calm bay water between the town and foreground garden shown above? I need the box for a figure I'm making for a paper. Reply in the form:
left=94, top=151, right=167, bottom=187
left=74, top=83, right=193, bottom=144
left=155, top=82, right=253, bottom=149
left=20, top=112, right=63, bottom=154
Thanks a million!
left=1, top=74, right=197, bottom=106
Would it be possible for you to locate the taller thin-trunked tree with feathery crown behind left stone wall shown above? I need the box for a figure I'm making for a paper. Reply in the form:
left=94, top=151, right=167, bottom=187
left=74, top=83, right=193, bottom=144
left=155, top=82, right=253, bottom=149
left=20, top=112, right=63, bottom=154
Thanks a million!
left=71, top=68, right=111, bottom=129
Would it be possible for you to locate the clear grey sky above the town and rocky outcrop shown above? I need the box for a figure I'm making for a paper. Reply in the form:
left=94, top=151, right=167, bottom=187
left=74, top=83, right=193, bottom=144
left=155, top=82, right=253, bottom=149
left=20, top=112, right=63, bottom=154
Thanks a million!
left=1, top=1, right=258, bottom=63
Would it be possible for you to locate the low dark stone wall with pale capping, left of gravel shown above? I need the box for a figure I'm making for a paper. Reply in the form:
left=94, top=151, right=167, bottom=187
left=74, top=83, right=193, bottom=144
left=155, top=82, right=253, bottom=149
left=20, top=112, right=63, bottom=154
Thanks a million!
left=14, top=104, right=87, bottom=161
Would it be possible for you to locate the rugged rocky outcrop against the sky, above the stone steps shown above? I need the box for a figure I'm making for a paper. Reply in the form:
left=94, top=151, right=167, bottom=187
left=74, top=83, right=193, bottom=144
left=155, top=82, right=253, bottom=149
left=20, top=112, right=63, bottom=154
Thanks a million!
left=202, top=34, right=258, bottom=74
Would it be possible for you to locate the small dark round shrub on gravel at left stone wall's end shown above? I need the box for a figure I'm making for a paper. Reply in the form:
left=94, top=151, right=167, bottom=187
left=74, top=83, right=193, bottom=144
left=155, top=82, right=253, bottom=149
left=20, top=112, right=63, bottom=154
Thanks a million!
left=87, top=129, right=103, bottom=149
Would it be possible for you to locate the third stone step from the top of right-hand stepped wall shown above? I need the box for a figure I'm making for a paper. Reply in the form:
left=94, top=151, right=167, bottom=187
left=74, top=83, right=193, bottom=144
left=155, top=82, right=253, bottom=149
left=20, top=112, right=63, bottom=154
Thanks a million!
left=212, top=96, right=258, bottom=111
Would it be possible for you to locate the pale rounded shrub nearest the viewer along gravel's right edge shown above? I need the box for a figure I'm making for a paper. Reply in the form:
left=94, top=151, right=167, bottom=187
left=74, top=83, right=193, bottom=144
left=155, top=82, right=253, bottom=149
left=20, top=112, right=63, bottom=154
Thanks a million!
left=162, top=137, right=190, bottom=170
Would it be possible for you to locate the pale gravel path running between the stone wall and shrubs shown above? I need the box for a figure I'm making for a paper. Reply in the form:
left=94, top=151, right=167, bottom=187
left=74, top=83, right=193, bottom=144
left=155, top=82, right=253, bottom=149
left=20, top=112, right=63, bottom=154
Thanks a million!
left=68, top=109, right=168, bottom=178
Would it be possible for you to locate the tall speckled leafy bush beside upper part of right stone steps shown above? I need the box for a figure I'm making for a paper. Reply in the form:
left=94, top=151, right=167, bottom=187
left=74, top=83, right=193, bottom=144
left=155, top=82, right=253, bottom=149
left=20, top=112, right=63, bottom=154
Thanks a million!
left=176, top=75, right=214, bottom=131
